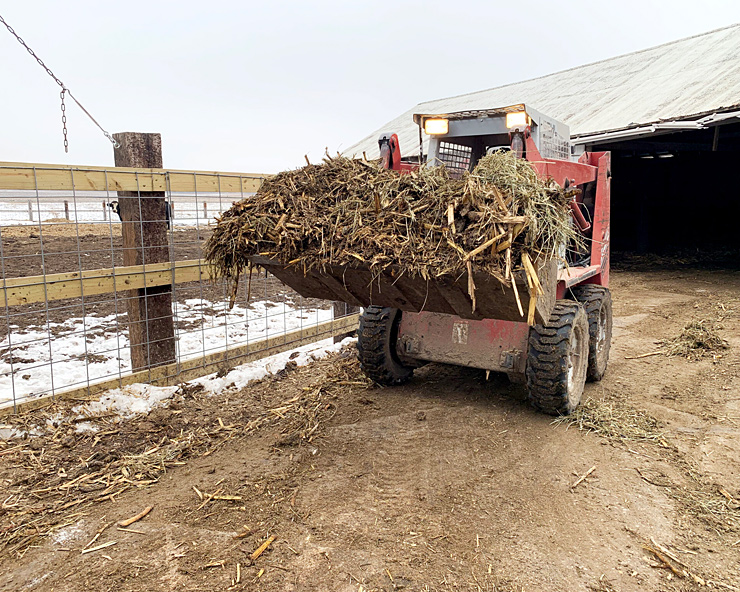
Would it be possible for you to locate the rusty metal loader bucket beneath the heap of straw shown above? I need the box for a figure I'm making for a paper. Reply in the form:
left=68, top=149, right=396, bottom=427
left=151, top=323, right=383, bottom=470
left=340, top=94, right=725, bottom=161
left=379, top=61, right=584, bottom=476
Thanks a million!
left=251, top=257, right=557, bottom=323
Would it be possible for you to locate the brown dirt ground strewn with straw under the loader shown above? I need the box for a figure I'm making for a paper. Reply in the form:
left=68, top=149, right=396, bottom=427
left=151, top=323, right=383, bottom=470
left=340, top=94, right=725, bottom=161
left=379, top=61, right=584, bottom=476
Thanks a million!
left=0, top=268, right=740, bottom=592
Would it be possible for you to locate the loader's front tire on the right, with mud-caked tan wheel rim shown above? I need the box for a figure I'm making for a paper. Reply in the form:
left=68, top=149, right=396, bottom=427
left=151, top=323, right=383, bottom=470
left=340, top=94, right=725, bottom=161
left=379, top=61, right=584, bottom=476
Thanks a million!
left=527, top=300, right=589, bottom=415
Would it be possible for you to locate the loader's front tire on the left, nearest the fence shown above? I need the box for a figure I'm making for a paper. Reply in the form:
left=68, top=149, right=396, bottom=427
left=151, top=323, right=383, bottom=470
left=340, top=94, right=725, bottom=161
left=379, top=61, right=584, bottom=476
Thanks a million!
left=357, top=306, right=414, bottom=386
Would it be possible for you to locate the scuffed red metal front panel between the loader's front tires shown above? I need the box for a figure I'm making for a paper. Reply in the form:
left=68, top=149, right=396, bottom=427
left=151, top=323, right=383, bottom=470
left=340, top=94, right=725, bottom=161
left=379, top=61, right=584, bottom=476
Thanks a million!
left=397, top=312, right=529, bottom=374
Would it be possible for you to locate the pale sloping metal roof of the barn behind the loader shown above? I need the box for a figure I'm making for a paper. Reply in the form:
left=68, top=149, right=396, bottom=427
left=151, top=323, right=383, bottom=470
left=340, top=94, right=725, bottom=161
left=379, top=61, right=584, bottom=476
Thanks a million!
left=344, top=23, right=740, bottom=158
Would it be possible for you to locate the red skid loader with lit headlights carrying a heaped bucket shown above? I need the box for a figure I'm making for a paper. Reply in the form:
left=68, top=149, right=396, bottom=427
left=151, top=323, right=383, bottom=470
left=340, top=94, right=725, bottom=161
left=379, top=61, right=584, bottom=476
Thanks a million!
left=254, top=104, right=612, bottom=415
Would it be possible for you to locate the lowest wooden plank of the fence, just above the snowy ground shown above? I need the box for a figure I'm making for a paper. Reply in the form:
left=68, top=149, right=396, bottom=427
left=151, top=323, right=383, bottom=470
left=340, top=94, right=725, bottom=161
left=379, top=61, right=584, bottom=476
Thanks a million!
left=0, top=315, right=360, bottom=417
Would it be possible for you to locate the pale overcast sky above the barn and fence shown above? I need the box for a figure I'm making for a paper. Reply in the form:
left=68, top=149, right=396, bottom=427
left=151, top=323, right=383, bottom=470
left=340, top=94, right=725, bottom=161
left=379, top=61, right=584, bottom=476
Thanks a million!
left=0, top=0, right=740, bottom=173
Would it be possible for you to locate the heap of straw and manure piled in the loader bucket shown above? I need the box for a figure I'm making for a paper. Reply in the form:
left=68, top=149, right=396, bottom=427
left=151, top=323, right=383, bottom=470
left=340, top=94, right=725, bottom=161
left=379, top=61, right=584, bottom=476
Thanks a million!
left=205, top=153, right=577, bottom=306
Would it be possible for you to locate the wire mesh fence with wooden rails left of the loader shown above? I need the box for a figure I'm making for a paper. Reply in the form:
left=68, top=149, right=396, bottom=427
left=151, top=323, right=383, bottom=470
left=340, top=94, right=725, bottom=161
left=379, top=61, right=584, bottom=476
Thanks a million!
left=0, top=165, right=354, bottom=408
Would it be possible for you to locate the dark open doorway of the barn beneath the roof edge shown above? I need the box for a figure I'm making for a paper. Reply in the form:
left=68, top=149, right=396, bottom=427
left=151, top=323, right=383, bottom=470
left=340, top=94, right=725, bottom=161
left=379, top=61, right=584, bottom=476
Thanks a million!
left=592, top=123, right=740, bottom=266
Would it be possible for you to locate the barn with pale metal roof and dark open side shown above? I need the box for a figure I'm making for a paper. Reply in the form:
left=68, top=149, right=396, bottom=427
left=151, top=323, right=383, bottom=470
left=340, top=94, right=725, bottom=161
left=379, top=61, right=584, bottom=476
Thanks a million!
left=345, top=24, right=740, bottom=256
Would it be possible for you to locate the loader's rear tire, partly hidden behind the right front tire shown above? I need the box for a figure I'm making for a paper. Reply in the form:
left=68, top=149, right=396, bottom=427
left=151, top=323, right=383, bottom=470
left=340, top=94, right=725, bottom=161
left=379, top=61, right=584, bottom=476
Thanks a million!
left=571, top=284, right=612, bottom=382
